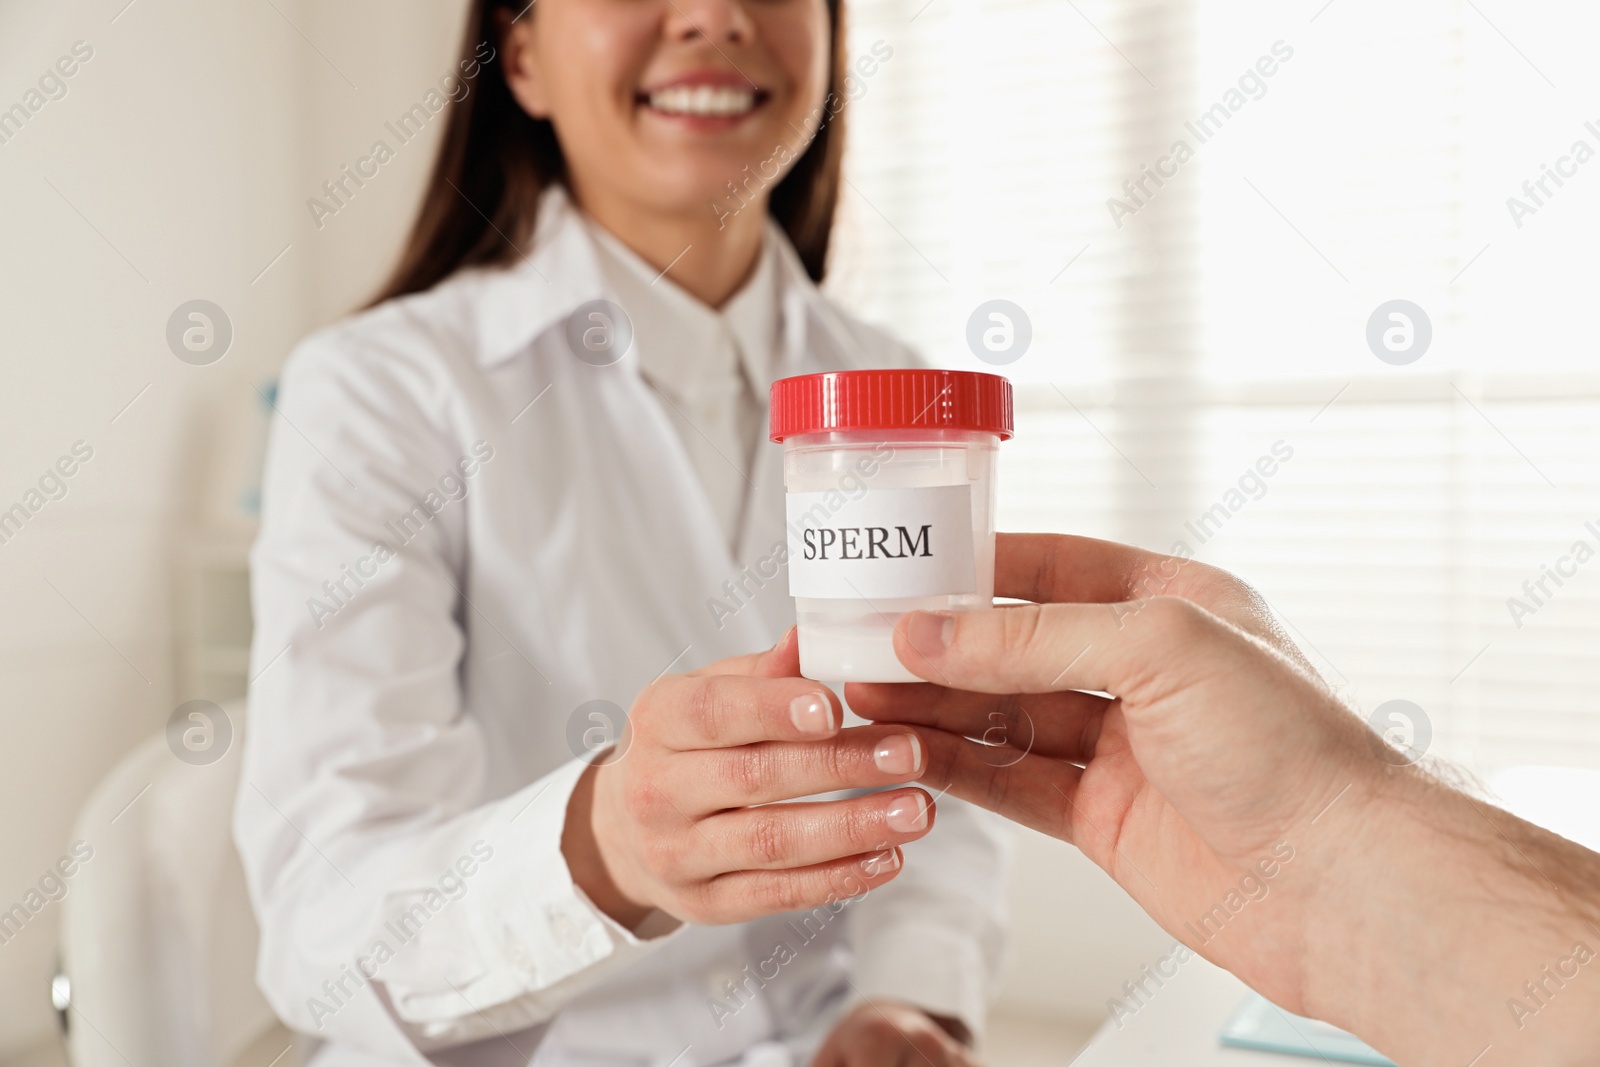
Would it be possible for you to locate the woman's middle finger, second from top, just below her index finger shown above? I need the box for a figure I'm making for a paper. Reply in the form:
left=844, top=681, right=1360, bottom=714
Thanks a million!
left=669, top=726, right=926, bottom=814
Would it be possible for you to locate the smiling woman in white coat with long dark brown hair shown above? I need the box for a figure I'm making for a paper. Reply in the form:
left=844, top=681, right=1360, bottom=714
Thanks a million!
left=235, top=0, right=1006, bottom=1067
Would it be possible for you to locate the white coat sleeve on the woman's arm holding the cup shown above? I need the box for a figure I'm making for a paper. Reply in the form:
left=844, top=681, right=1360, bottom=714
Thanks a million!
left=234, top=336, right=666, bottom=1062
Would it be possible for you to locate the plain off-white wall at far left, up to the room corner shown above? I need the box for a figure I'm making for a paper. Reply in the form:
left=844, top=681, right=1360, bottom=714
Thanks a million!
left=0, top=0, right=302, bottom=1049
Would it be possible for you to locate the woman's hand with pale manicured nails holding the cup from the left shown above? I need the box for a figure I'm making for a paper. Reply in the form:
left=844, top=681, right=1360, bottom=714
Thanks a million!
left=562, top=630, right=934, bottom=926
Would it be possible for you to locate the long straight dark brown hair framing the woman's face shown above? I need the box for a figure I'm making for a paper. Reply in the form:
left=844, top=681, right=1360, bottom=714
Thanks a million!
left=373, top=0, right=846, bottom=304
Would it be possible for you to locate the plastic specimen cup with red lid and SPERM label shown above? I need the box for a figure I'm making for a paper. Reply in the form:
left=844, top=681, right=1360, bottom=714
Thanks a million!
left=771, top=370, right=1013, bottom=681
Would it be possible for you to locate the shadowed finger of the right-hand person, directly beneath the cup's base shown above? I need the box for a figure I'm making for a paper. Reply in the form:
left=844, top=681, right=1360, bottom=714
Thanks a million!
left=845, top=681, right=1110, bottom=763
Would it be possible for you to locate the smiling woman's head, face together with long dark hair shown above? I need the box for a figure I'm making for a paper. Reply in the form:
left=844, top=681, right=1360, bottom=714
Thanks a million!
left=373, top=0, right=851, bottom=306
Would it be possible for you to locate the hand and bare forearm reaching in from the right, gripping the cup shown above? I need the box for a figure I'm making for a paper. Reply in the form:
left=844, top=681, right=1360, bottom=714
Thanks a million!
left=846, top=536, right=1600, bottom=1067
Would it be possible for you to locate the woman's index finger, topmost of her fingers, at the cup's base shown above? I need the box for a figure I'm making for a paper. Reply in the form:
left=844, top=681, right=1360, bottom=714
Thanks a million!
left=632, top=675, right=843, bottom=752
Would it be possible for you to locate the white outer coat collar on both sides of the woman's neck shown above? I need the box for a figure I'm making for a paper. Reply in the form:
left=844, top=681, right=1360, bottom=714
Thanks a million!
left=475, top=186, right=822, bottom=377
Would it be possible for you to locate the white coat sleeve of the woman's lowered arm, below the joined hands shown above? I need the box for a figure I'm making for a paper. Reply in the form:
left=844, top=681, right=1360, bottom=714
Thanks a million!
left=850, top=777, right=1013, bottom=1037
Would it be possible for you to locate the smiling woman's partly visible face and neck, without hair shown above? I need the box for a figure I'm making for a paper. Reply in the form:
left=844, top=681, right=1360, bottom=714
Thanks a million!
left=502, top=0, right=843, bottom=246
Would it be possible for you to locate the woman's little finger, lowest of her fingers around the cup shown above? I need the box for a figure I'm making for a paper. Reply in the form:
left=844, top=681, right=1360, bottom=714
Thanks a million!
left=686, top=848, right=904, bottom=928
